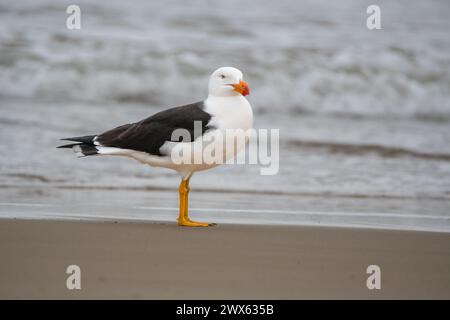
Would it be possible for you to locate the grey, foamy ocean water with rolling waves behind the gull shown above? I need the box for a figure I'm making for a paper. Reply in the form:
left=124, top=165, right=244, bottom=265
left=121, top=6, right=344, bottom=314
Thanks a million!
left=0, top=0, right=450, bottom=232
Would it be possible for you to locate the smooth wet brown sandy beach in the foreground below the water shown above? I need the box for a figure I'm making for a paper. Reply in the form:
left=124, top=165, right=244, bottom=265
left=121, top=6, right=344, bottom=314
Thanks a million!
left=0, top=219, right=450, bottom=299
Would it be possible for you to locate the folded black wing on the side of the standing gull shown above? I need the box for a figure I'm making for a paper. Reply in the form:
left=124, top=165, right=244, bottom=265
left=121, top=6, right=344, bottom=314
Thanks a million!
left=97, top=101, right=211, bottom=155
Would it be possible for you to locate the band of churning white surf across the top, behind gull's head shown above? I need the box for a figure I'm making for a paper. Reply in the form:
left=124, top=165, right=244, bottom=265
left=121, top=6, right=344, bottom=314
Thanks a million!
left=0, top=0, right=450, bottom=119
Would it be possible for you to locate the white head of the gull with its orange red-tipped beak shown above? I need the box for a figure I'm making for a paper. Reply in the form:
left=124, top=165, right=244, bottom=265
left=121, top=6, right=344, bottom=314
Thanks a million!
left=209, top=67, right=250, bottom=97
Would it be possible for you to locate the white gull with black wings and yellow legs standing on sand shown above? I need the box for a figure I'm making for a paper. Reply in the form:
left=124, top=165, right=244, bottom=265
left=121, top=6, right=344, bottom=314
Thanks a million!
left=58, top=67, right=253, bottom=227
